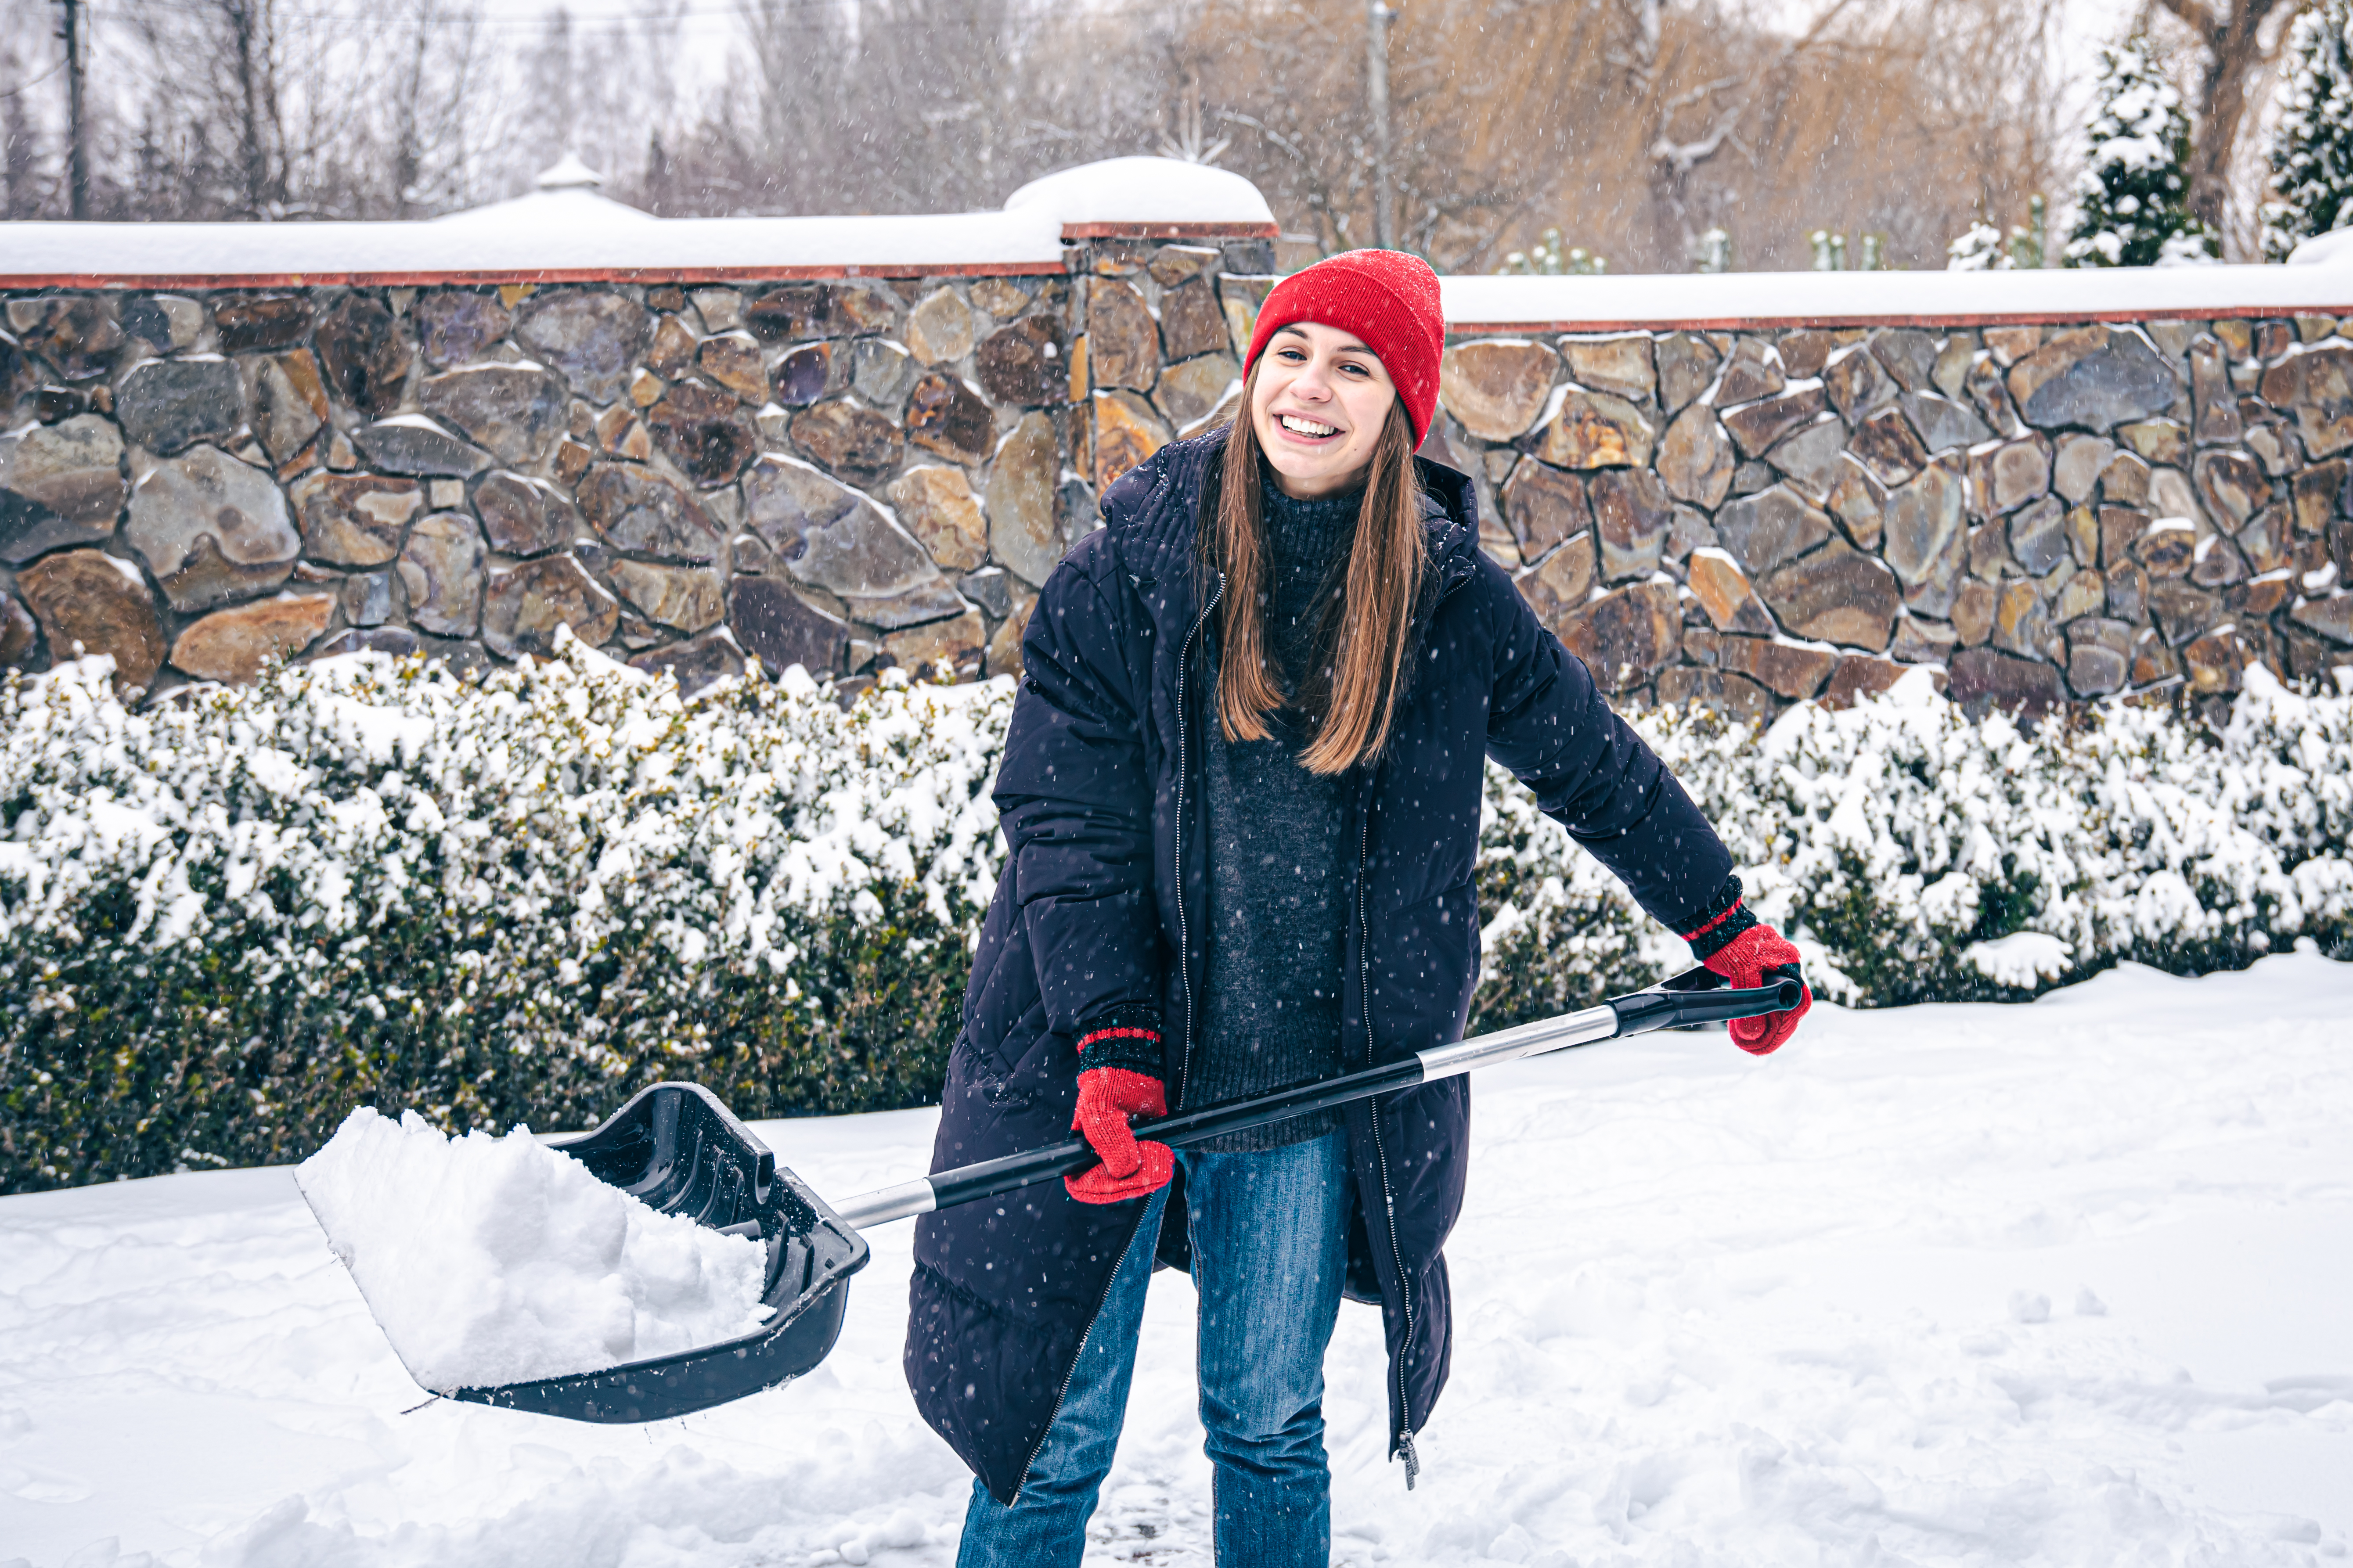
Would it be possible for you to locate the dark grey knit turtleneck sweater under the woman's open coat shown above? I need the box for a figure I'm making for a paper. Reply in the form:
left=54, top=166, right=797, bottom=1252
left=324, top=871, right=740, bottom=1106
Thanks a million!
left=1184, top=472, right=1362, bottom=1152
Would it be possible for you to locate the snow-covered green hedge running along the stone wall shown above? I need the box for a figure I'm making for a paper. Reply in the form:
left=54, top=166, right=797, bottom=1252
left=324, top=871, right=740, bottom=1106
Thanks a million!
left=0, top=647, right=2353, bottom=1192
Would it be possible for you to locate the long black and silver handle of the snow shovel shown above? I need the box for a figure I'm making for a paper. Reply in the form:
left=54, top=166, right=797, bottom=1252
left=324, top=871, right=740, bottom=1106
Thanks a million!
left=833, top=968, right=1802, bottom=1230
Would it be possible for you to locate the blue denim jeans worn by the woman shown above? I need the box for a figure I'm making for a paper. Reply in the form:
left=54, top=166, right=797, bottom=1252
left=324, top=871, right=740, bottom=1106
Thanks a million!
left=955, top=1131, right=1348, bottom=1568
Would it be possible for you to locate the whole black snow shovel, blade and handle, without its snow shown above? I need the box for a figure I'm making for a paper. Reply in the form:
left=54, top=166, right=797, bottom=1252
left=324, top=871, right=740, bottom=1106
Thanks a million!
left=450, top=968, right=1798, bottom=1422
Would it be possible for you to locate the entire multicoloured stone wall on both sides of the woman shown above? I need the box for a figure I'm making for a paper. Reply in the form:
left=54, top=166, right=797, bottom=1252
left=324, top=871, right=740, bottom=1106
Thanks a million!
left=0, top=257, right=2353, bottom=715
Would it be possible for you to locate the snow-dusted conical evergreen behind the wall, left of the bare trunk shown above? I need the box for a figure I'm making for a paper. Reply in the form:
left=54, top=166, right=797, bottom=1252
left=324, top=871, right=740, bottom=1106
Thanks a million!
left=2066, top=35, right=2221, bottom=266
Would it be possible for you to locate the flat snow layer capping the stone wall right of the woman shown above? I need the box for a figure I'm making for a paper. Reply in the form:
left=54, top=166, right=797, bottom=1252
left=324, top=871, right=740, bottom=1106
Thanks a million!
left=1438, top=257, right=2353, bottom=331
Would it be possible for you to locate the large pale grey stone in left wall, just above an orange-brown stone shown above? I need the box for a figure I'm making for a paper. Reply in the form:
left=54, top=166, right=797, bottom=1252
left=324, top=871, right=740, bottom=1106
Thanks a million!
left=128, top=447, right=301, bottom=611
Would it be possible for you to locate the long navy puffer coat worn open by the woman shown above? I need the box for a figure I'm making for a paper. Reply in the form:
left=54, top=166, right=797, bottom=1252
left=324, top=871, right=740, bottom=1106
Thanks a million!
left=906, top=430, right=1732, bottom=1502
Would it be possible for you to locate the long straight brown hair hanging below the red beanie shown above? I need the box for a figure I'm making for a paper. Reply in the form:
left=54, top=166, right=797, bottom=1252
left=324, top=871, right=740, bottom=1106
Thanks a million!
left=1200, top=360, right=1423, bottom=773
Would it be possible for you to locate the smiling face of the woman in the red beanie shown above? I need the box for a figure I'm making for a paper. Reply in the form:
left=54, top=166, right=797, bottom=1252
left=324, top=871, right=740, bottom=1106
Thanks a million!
left=1250, top=322, right=1398, bottom=501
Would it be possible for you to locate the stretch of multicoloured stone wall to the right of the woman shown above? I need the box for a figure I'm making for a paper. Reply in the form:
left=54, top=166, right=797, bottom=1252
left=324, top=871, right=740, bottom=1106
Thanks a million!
left=1440, top=315, right=2353, bottom=712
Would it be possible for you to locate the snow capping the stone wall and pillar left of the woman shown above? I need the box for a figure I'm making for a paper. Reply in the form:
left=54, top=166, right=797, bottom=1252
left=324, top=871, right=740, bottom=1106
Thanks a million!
left=0, top=158, right=1276, bottom=287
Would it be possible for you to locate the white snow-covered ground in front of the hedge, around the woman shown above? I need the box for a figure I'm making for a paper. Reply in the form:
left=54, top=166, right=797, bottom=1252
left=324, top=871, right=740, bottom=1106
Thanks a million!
left=0, top=952, right=2353, bottom=1568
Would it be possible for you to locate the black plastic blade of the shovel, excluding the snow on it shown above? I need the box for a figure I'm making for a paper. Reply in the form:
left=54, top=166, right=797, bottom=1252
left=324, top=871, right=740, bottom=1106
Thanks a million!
left=450, top=1084, right=868, bottom=1422
